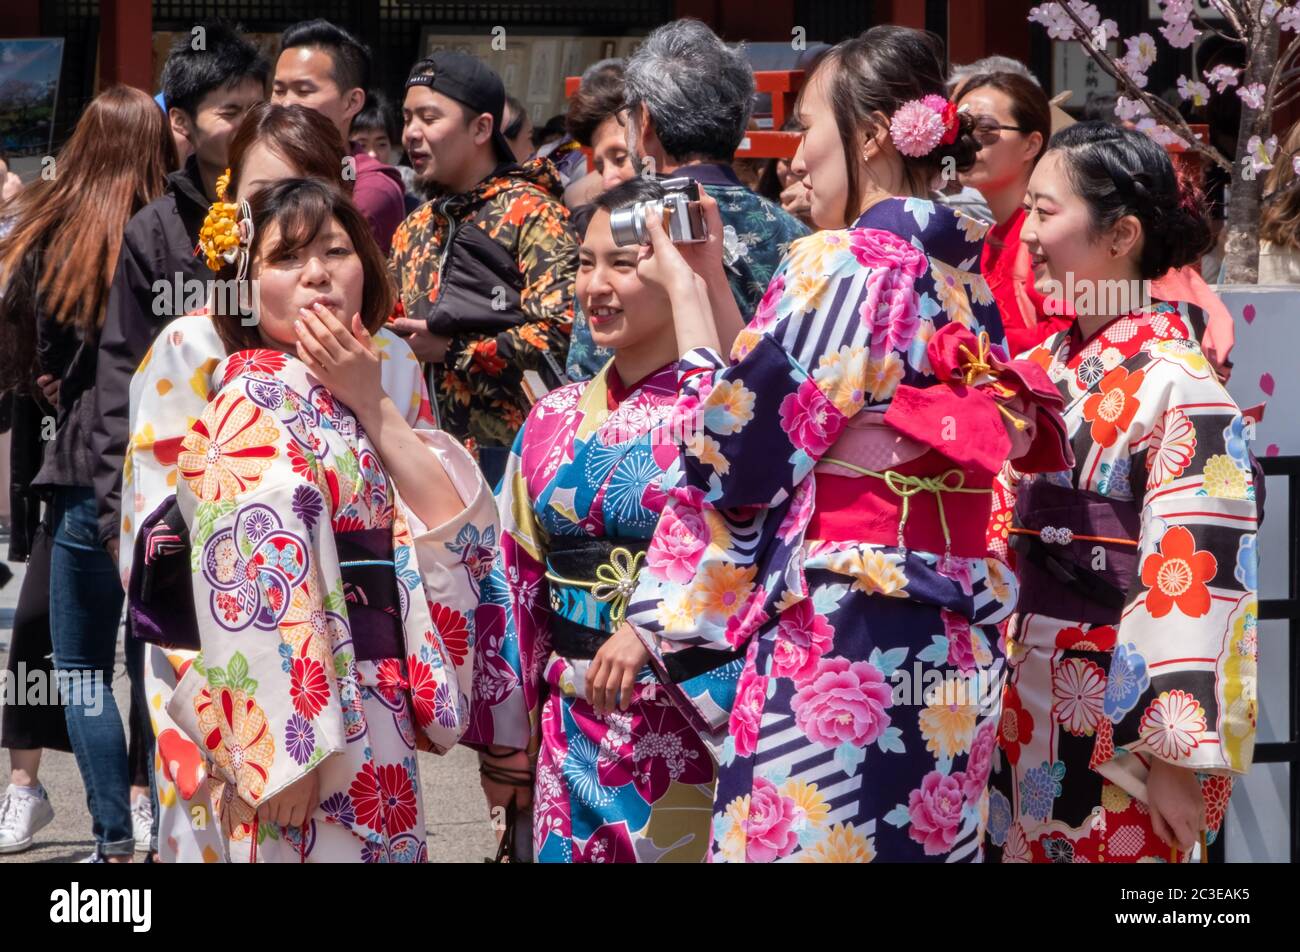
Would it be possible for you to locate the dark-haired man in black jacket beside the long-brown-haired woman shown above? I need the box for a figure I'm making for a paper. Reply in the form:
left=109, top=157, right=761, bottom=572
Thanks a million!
left=91, top=23, right=269, bottom=559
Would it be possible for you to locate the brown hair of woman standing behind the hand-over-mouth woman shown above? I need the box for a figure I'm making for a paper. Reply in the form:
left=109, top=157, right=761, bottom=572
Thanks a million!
left=230, top=101, right=354, bottom=195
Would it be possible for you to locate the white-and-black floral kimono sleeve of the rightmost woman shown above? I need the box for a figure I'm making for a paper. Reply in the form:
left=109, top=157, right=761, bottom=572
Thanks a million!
left=1084, top=341, right=1258, bottom=789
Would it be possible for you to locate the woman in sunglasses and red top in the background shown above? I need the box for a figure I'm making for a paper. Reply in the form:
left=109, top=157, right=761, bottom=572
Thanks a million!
left=957, top=73, right=1070, bottom=356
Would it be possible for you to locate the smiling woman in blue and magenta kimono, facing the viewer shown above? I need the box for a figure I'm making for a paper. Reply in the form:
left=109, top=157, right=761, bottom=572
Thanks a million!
left=463, top=178, right=717, bottom=862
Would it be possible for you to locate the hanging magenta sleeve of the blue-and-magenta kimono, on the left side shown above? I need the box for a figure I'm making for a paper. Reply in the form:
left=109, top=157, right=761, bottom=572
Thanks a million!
left=462, top=424, right=550, bottom=750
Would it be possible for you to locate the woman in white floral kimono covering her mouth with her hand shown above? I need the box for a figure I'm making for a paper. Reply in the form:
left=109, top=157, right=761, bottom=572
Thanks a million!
left=127, top=179, right=494, bottom=861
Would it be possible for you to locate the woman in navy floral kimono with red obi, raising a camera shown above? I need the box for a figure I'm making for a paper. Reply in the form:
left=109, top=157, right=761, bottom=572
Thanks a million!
left=631, top=27, right=1066, bottom=862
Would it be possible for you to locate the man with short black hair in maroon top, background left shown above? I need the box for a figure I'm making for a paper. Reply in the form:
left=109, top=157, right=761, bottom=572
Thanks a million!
left=270, top=20, right=406, bottom=255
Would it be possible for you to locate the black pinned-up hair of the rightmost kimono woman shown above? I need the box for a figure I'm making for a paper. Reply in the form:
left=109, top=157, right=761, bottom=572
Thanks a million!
left=1048, top=122, right=1213, bottom=281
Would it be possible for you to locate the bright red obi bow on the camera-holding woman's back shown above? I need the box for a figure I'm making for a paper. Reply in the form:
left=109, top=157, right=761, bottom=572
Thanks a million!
left=885, top=324, right=1074, bottom=473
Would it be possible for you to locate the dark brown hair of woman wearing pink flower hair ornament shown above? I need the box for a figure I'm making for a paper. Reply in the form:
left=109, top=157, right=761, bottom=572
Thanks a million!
left=805, top=26, right=979, bottom=224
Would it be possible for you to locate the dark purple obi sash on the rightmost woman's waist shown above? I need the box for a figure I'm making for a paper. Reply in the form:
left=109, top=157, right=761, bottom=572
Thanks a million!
left=1010, top=477, right=1141, bottom=624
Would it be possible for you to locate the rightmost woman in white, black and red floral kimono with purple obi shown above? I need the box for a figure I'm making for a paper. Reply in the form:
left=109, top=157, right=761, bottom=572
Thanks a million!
left=989, top=122, right=1262, bottom=862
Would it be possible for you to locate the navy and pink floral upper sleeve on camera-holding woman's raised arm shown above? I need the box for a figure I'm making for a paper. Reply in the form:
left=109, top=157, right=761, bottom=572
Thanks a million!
left=677, top=230, right=930, bottom=509
